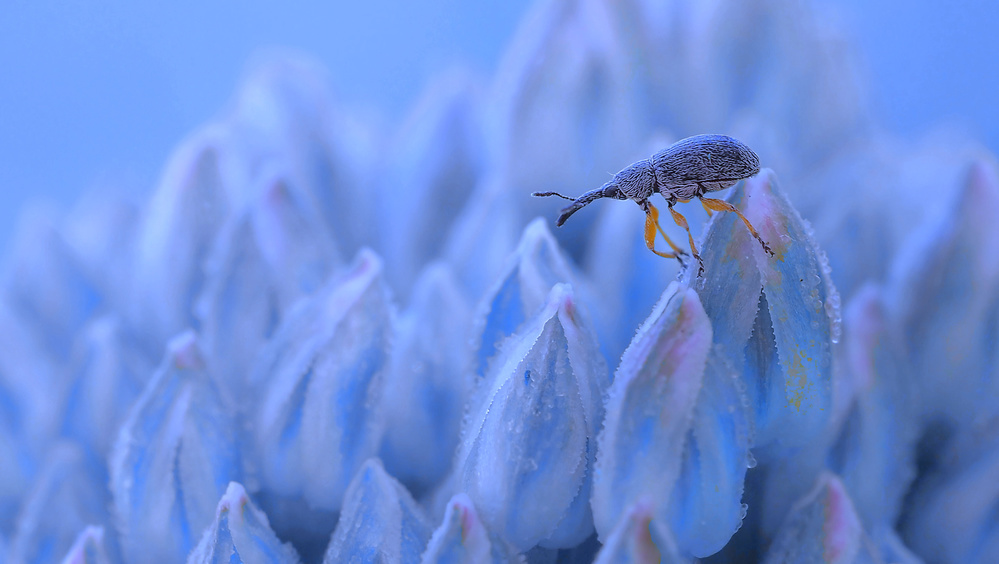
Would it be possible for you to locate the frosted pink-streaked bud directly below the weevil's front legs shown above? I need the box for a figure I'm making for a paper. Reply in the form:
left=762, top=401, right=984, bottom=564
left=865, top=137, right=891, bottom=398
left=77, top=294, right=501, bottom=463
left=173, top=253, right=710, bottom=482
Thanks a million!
left=593, top=283, right=749, bottom=556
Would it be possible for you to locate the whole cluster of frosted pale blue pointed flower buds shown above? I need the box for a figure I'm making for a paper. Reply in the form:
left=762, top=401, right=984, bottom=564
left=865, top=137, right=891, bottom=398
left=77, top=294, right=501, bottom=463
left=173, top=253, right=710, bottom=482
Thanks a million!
left=0, top=0, right=999, bottom=564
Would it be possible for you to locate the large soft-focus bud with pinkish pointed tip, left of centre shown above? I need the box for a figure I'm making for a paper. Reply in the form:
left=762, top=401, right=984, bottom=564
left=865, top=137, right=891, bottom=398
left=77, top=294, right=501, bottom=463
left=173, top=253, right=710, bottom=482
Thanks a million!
left=253, top=250, right=392, bottom=511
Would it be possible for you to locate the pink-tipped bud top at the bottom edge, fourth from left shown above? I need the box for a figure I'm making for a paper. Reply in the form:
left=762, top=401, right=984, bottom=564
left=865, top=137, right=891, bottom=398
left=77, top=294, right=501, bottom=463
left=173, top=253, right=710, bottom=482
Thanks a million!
left=420, top=493, right=524, bottom=564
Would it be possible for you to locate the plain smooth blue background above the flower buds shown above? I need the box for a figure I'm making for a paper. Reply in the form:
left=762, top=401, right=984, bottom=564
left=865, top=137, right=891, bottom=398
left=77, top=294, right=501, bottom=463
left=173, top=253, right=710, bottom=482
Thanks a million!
left=0, top=0, right=999, bottom=254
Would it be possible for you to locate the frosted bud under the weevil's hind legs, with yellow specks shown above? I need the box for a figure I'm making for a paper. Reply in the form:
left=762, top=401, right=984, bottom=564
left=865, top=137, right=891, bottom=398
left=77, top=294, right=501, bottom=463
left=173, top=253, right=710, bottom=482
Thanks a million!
left=685, top=170, right=840, bottom=449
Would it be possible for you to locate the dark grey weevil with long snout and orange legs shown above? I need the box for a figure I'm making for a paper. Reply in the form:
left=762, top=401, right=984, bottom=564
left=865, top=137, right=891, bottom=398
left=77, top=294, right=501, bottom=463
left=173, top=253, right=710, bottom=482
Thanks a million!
left=532, top=135, right=774, bottom=276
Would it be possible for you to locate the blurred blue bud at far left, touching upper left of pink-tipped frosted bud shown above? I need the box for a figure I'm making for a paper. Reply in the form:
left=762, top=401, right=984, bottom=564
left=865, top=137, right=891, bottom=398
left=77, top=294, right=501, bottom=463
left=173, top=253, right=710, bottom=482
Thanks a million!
left=60, top=316, right=155, bottom=460
